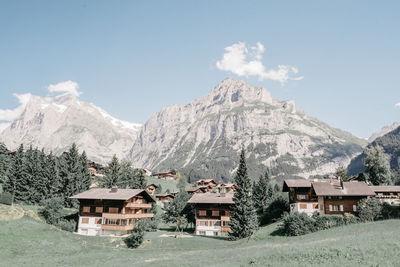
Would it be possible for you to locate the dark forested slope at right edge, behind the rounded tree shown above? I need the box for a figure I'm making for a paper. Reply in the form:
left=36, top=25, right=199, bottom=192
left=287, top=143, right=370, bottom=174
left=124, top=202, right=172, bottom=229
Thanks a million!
left=348, top=125, right=400, bottom=177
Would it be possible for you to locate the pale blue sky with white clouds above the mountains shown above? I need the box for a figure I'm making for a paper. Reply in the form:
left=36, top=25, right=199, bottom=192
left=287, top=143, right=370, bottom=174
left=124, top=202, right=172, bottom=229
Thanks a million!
left=0, top=0, right=400, bottom=138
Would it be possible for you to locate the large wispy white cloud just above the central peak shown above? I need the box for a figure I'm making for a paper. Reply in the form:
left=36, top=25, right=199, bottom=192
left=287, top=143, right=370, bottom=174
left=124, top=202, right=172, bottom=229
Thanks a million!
left=216, top=42, right=304, bottom=84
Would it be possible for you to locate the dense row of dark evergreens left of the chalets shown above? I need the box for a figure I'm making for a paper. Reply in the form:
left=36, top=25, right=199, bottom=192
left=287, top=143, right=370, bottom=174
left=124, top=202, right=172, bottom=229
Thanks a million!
left=0, top=144, right=91, bottom=207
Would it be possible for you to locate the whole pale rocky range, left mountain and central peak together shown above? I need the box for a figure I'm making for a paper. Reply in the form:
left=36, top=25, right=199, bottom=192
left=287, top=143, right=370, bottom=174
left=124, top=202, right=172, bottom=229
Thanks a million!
left=0, top=78, right=367, bottom=181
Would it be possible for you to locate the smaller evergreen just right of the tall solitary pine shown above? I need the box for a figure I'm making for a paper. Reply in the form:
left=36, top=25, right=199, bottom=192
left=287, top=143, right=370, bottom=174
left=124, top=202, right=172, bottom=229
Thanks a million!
left=253, top=172, right=274, bottom=212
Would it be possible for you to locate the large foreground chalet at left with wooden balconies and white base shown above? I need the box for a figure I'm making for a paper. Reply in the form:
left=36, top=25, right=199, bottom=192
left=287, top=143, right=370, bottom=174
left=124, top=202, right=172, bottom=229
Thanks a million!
left=71, top=188, right=155, bottom=235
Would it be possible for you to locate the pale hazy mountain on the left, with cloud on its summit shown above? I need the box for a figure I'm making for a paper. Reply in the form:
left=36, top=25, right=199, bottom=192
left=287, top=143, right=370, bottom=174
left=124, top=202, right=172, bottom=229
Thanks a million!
left=0, top=94, right=141, bottom=163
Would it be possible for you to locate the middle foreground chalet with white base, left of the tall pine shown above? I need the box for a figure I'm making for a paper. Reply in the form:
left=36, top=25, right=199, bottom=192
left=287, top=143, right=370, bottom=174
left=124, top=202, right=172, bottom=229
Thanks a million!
left=188, top=193, right=235, bottom=239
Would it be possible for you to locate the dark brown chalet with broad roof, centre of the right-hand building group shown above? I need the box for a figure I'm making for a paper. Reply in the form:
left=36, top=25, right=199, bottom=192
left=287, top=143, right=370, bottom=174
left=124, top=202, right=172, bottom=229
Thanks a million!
left=311, top=180, right=375, bottom=215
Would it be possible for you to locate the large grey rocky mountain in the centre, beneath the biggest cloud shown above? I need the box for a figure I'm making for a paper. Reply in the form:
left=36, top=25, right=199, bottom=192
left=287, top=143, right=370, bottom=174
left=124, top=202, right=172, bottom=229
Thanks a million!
left=130, top=78, right=366, bottom=180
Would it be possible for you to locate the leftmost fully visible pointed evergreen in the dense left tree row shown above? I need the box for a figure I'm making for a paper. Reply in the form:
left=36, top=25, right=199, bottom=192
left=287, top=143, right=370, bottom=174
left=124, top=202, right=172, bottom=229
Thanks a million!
left=4, top=144, right=30, bottom=203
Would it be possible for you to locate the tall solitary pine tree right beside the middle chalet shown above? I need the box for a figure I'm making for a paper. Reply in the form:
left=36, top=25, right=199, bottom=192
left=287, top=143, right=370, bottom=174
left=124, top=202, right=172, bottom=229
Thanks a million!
left=229, top=149, right=258, bottom=240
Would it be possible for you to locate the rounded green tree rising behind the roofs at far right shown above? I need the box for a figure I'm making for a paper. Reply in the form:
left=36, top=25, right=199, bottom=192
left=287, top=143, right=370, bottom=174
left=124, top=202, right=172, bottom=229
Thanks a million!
left=365, top=146, right=392, bottom=185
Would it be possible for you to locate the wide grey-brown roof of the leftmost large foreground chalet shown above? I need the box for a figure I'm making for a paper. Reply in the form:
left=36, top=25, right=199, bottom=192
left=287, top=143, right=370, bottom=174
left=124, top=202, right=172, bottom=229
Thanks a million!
left=70, top=188, right=154, bottom=201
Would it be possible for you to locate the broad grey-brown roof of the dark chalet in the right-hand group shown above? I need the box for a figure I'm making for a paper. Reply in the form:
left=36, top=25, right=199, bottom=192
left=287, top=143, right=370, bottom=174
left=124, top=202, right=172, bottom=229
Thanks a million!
left=312, top=181, right=375, bottom=196
